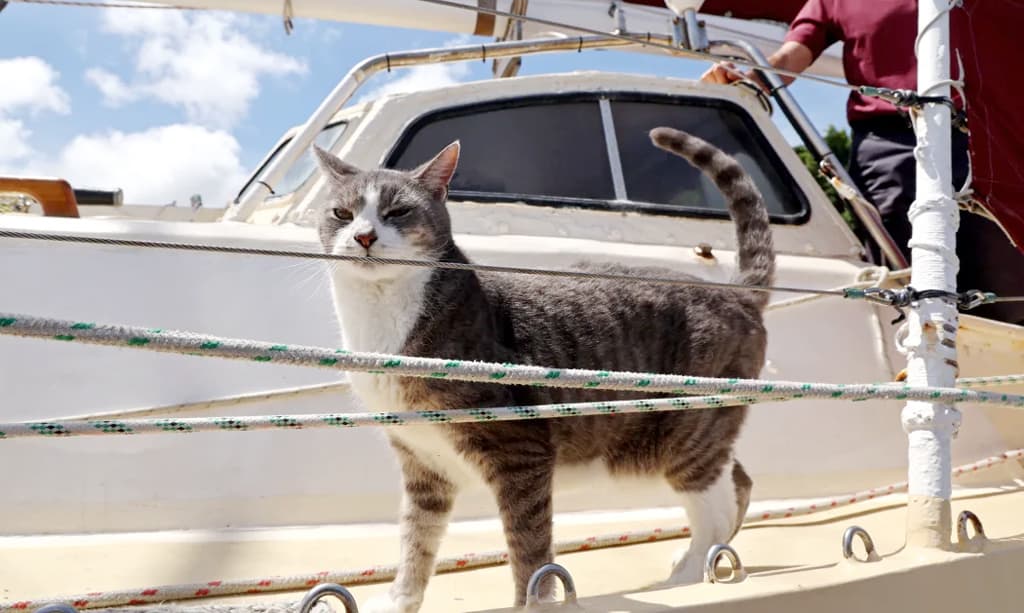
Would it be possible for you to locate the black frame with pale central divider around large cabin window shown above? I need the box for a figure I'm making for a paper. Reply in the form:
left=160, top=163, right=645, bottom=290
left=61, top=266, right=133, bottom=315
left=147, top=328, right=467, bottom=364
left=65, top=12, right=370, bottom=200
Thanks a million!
left=381, top=90, right=811, bottom=225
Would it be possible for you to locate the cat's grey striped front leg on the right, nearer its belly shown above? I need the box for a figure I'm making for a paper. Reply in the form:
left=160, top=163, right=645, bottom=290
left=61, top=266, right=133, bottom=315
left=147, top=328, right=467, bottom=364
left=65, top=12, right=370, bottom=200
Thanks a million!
left=487, top=441, right=554, bottom=607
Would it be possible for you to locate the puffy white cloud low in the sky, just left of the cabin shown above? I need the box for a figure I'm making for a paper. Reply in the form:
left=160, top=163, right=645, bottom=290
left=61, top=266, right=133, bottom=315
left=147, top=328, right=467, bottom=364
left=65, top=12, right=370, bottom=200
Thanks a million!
left=49, top=124, right=247, bottom=207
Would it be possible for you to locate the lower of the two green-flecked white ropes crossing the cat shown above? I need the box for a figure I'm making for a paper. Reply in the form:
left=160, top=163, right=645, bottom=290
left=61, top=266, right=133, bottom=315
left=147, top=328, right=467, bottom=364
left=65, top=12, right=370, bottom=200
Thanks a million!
left=0, top=394, right=774, bottom=439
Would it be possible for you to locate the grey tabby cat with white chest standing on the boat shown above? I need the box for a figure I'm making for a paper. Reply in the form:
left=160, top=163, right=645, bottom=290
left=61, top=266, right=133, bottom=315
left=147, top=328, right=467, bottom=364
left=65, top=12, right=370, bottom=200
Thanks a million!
left=314, top=128, right=775, bottom=613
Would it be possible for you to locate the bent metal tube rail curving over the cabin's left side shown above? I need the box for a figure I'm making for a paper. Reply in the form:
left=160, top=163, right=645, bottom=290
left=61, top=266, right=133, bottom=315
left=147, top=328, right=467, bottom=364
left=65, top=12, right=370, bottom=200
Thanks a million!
left=224, top=36, right=643, bottom=221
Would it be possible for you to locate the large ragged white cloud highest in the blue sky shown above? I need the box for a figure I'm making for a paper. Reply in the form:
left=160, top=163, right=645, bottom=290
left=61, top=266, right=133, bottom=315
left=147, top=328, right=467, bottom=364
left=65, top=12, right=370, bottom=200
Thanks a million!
left=86, top=9, right=307, bottom=127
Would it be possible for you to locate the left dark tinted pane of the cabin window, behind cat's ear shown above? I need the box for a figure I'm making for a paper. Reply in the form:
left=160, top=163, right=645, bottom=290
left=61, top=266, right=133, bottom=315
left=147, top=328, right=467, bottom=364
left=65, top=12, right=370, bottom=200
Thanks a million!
left=387, top=99, right=615, bottom=201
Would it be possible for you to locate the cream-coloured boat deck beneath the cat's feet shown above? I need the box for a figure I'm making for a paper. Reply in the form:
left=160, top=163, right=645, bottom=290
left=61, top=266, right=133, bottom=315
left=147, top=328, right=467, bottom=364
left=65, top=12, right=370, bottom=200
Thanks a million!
left=8, top=488, right=1024, bottom=613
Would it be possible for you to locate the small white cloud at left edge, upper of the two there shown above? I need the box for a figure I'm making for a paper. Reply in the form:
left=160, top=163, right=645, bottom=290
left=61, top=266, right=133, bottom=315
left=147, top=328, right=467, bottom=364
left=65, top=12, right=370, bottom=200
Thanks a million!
left=0, top=57, right=71, bottom=117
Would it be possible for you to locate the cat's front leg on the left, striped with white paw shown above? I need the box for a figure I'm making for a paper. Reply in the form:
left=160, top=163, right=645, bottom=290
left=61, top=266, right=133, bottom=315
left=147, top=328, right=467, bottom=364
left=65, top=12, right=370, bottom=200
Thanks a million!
left=359, top=440, right=455, bottom=613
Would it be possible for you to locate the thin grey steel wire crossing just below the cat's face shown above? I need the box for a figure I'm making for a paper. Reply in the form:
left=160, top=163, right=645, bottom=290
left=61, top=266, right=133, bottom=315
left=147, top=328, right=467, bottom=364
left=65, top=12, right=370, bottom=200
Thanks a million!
left=0, top=229, right=843, bottom=298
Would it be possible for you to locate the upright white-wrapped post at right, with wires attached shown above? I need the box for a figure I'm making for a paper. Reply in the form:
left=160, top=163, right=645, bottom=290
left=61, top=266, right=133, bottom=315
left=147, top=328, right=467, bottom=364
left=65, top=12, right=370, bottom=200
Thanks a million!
left=901, top=0, right=961, bottom=549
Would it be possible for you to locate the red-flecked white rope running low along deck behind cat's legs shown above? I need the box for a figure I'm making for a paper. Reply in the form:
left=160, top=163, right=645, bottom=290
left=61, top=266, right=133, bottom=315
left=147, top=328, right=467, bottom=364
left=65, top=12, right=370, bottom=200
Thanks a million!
left=6, top=449, right=1024, bottom=613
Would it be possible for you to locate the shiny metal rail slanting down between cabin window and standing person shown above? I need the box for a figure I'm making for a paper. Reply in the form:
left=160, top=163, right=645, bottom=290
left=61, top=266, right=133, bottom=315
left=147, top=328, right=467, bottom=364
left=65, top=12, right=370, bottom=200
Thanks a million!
left=711, top=40, right=908, bottom=269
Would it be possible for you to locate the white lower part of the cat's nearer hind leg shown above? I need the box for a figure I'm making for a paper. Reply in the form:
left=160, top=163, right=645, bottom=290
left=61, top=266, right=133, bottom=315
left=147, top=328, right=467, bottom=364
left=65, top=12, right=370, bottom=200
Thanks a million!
left=669, top=461, right=739, bottom=584
